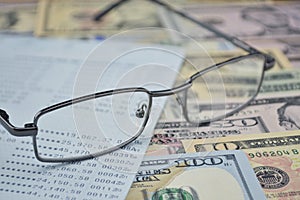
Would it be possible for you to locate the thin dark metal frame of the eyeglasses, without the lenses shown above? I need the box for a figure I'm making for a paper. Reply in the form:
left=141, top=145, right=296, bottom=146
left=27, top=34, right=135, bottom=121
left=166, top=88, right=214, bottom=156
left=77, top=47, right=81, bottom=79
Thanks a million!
left=0, top=0, right=275, bottom=162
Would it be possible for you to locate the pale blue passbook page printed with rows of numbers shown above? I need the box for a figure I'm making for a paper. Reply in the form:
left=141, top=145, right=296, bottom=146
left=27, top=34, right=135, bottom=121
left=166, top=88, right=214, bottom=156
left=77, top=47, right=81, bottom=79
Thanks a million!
left=0, top=37, right=182, bottom=199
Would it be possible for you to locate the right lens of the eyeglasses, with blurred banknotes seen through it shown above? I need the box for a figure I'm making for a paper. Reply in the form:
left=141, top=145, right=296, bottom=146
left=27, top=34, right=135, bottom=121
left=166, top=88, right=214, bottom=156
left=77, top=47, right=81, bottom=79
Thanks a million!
left=186, top=55, right=264, bottom=123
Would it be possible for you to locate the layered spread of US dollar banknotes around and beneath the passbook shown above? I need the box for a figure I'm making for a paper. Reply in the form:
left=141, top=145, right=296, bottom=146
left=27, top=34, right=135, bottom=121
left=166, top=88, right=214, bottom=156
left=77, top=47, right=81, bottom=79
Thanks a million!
left=0, top=0, right=300, bottom=200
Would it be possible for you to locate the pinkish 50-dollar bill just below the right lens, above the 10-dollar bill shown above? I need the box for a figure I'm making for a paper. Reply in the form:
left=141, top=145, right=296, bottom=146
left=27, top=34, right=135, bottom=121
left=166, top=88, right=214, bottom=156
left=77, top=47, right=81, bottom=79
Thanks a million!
left=147, top=96, right=300, bottom=155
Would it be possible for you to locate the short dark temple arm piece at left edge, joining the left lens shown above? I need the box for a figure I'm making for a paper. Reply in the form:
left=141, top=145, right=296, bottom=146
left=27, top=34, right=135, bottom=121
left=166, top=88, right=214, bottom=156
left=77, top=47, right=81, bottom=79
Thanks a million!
left=0, top=109, right=37, bottom=137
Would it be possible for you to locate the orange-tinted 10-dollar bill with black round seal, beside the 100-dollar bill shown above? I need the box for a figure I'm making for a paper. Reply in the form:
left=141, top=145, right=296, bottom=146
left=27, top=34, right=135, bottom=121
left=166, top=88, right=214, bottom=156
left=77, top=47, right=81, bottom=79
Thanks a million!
left=182, top=131, right=300, bottom=200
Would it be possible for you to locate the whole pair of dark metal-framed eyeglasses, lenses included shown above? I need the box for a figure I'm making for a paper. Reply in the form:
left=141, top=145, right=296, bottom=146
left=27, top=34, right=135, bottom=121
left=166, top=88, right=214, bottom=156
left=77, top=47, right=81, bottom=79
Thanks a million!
left=0, top=0, right=275, bottom=162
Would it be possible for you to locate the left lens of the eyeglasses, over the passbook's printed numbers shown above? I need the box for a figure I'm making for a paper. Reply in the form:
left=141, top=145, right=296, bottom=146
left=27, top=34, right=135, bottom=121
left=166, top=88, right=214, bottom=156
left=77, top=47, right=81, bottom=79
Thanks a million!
left=37, top=91, right=151, bottom=159
